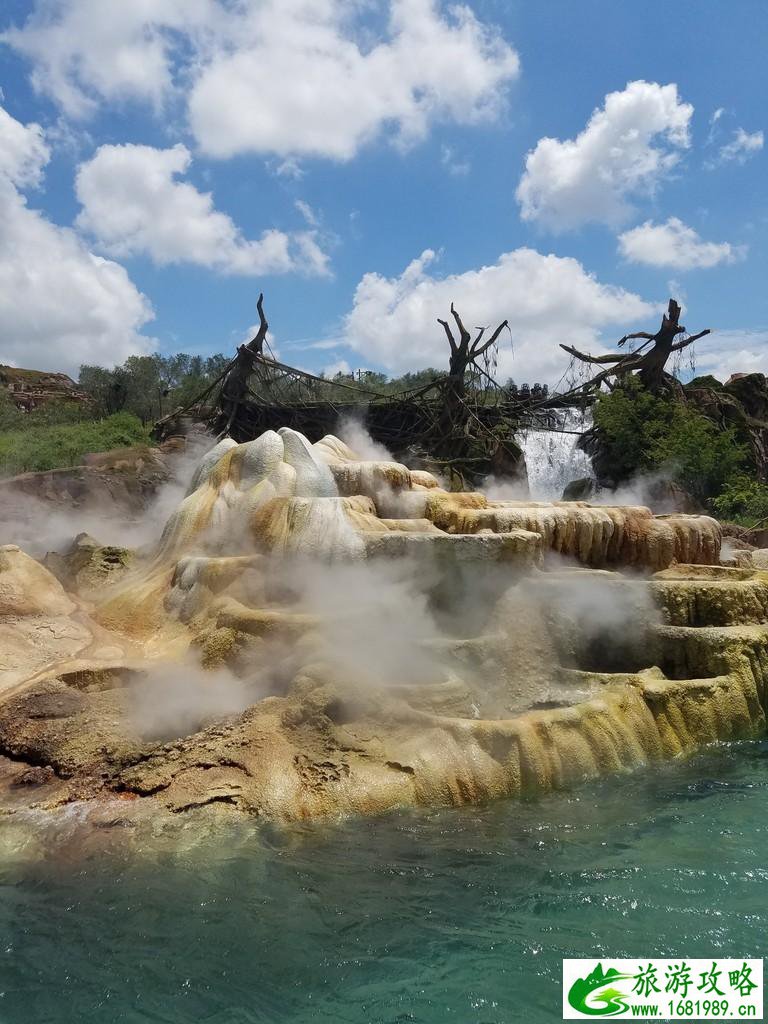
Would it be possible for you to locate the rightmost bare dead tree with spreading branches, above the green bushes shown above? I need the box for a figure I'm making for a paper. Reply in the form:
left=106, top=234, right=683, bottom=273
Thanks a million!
left=560, top=299, right=710, bottom=394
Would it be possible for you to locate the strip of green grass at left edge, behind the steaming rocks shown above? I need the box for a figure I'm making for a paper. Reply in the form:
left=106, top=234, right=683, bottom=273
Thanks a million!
left=0, top=413, right=150, bottom=476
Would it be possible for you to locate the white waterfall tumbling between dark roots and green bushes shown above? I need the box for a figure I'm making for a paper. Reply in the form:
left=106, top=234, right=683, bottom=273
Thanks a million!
left=515, top=410, right=595, bottom=502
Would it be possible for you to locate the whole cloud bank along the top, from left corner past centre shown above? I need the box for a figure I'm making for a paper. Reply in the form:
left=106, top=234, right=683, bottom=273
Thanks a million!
left=2, top=0, right=519, bottom=159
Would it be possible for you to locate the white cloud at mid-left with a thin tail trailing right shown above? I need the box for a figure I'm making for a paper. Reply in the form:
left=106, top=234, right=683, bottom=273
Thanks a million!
left=76, top=144, right=329, bottom=275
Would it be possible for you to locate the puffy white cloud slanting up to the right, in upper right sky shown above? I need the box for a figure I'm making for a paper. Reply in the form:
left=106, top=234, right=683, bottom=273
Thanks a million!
left=516, top=81, right=693, bottom=230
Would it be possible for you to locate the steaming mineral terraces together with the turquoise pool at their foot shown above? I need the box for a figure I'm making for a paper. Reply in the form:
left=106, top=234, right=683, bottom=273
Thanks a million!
left=0, top=428, right=768, bottom=1024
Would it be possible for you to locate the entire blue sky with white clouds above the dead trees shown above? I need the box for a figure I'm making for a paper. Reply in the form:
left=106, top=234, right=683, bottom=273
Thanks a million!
left=0, top=0, right=768, bottom=384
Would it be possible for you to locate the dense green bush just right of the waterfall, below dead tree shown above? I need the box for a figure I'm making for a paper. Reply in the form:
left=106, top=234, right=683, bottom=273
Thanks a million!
left=595, top=377, right=746, bottom=502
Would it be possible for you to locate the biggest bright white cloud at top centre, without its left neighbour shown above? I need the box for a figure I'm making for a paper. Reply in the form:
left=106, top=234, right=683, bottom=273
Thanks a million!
left=189, top=0, right=519, bottom=160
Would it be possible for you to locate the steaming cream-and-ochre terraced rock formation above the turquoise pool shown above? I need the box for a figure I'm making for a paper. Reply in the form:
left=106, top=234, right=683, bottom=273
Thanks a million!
left=0, top=428, right=768, bottom=821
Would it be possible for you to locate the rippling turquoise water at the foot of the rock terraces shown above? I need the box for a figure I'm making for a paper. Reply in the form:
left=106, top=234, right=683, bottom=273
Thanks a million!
left=0, top=743, right=768, bottom=1024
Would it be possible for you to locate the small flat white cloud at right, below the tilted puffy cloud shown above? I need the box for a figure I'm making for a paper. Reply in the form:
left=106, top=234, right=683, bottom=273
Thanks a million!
left=618, top=217, right=745, bottom=270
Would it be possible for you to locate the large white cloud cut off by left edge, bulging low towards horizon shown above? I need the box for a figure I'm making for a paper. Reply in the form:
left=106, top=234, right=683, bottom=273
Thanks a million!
left=0, top=108, right=153, bottom=375
